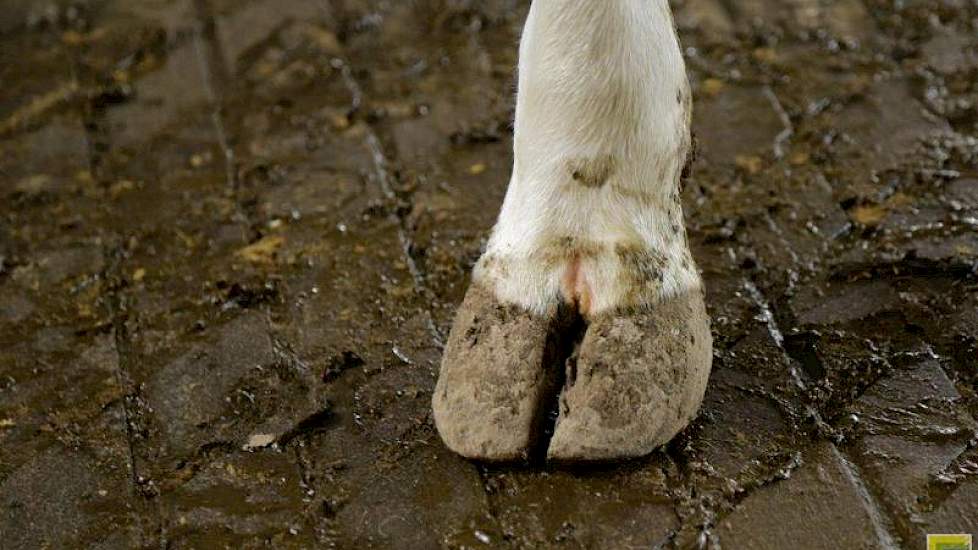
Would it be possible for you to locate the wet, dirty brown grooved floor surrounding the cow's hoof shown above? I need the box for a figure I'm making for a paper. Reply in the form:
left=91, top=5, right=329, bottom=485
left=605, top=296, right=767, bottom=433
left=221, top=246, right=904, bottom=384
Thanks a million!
left=0, top=0, right=978, bottom=549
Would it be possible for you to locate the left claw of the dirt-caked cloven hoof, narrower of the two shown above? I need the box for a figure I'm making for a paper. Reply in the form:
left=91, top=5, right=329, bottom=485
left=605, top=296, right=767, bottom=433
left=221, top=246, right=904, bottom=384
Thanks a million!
left=432, top=284, right=560, bottom=461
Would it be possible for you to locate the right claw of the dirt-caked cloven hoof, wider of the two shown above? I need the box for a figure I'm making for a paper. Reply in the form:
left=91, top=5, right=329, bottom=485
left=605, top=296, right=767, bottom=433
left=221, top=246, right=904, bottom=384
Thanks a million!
left=547, top=289, right=713, bottom=462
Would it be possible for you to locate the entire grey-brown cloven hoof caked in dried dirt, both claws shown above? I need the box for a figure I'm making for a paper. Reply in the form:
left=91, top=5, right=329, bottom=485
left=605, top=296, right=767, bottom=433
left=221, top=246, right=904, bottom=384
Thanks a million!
left=433, top=284, right=712, bottom=462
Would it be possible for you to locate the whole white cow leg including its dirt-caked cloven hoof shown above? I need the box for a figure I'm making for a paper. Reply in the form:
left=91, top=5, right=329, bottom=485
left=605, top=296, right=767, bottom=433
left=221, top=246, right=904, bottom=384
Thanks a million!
left=433, top=0, right=712, bottom=461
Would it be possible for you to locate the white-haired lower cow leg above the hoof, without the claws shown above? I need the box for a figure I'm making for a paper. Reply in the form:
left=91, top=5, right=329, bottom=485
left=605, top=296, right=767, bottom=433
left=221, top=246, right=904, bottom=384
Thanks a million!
left=474, top=0, right=700, bottom=320
